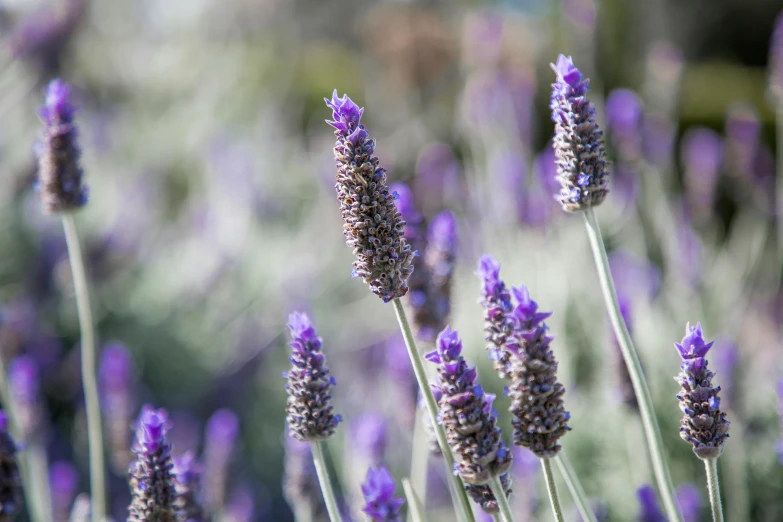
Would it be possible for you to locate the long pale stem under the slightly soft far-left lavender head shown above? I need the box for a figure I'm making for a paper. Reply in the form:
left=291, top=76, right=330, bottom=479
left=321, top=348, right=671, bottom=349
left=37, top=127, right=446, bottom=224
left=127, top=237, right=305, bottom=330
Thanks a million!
left=62, top=212, right=106, bottom=522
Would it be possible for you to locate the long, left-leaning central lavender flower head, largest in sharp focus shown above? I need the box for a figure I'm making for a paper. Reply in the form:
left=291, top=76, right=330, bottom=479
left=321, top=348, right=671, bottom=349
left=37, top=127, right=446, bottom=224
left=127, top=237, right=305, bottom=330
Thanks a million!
left=324, top=90, right=413, bottom=302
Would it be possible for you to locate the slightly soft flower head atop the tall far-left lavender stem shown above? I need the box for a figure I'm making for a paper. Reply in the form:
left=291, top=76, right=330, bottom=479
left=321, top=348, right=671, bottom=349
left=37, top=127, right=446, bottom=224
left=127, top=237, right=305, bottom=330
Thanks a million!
left=36, top=80, right=87, bottom=214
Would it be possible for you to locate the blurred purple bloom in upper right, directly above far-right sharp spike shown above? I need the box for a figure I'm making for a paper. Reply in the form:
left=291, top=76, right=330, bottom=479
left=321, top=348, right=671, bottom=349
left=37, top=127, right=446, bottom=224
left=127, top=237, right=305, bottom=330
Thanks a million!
left=680, top=127, right=723, bottom=214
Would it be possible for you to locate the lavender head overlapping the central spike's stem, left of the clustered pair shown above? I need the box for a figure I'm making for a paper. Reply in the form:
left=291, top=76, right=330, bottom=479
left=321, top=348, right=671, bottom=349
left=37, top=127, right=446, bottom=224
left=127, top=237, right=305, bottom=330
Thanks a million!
left=425, top=326, right=513, bottom=485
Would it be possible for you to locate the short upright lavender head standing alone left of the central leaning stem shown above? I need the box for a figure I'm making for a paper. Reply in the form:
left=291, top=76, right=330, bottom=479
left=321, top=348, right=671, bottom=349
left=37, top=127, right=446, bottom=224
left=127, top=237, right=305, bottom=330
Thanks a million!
left=284, top=312, right=342, bottom=441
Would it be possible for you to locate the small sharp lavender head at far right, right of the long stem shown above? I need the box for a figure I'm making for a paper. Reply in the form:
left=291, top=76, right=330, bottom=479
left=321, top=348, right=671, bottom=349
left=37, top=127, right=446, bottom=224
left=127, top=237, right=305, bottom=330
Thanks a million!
left=674, top=323, right=729, bottom=459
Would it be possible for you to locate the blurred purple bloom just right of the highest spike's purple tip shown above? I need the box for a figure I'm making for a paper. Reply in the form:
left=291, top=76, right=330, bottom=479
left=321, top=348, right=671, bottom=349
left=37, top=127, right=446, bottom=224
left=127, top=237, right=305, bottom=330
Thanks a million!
left=605, top=89, right=643, bottom=162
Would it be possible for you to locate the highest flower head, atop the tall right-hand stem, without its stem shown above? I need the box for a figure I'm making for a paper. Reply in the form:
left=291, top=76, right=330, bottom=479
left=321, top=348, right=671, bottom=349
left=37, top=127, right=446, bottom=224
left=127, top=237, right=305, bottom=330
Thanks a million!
left=549, top=54, right=609, bottom=212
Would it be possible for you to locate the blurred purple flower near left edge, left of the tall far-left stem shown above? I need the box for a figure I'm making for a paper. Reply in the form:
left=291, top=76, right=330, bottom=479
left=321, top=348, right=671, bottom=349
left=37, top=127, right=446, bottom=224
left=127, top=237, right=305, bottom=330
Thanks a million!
left=8, top=355, right=44, bottom=434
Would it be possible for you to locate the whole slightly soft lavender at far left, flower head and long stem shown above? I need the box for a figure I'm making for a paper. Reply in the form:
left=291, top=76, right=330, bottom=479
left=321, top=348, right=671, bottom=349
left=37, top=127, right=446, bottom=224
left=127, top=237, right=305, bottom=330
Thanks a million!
left=36, top=79, right=106, bottom=522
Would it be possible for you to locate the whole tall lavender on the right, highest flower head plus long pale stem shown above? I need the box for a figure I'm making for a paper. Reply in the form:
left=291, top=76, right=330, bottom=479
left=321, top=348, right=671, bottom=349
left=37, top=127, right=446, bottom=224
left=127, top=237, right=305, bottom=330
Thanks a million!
left=550, top=55, right=682, bottom=522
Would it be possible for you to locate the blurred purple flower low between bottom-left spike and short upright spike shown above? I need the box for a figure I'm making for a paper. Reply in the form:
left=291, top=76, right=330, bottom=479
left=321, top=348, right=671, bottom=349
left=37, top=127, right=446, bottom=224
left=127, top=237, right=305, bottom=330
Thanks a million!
left=204, top=408, right=239, bottom=513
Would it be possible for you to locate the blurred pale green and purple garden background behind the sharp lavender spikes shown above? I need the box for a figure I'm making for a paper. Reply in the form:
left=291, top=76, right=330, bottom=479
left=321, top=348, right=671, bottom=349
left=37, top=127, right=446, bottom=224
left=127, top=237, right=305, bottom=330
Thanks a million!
left=0, top=0, right=783, bottom=522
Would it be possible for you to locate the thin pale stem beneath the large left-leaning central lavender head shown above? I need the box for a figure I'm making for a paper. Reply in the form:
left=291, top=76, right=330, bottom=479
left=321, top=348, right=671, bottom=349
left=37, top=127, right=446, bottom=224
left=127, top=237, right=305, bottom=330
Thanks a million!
left=393, top=298, right=476, bottom=522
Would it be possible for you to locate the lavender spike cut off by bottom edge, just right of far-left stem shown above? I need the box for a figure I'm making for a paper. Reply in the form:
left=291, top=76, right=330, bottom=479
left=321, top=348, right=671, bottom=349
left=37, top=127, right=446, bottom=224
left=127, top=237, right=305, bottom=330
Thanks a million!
left=128, top=404, right=180, bottom=522
